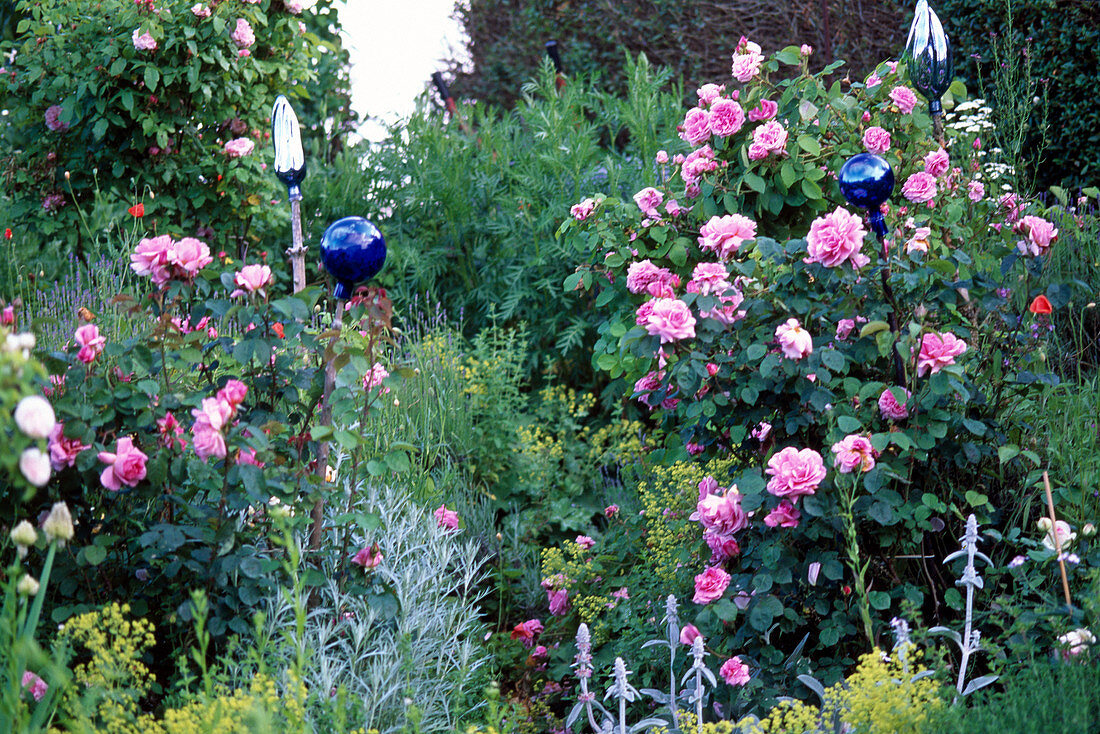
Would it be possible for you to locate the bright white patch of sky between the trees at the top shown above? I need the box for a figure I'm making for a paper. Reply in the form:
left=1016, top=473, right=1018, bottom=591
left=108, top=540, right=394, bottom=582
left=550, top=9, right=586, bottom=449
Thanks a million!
left=340, top=0, right=462, bottom=140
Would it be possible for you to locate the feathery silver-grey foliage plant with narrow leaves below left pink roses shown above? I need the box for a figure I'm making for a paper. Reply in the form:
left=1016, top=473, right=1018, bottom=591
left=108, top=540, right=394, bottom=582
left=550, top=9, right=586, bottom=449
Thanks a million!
left=233, top=468, right=488, bottom=734
